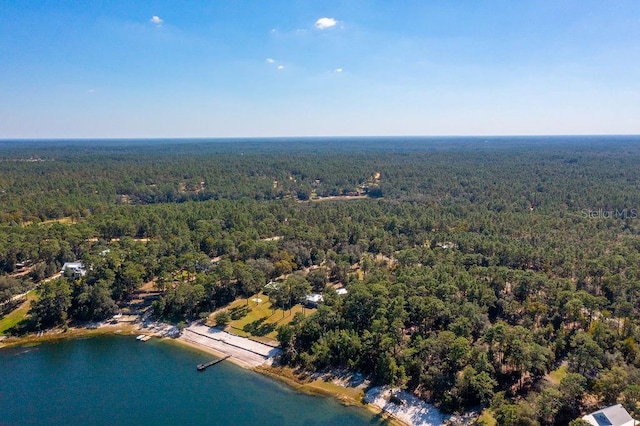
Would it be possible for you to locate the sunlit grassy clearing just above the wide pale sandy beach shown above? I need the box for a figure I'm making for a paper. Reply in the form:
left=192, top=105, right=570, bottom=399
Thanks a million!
left=215, top=293, right=315, bottom=343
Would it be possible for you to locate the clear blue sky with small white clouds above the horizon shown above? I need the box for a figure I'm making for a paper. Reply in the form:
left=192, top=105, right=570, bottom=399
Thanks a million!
left=0, top=0, right=640, bottom=138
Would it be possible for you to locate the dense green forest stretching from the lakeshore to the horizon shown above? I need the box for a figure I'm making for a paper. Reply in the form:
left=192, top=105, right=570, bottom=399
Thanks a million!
left=0, top=137, right=640, bottom=425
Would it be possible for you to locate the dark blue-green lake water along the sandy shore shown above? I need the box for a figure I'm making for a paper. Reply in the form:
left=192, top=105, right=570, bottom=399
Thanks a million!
left=0, top=336, right=380, bottom=426
